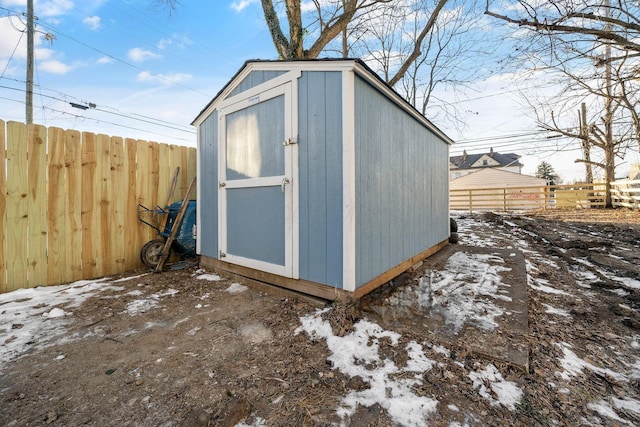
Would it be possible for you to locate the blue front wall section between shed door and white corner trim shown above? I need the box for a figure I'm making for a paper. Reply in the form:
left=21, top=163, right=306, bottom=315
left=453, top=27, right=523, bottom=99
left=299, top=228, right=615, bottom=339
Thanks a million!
left=298, top=71, right=343, bottom=288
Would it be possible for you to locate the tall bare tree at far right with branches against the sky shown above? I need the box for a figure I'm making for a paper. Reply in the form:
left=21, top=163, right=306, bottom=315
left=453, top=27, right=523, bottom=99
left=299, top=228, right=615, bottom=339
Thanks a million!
left=485, top=0, right=640, bottom=207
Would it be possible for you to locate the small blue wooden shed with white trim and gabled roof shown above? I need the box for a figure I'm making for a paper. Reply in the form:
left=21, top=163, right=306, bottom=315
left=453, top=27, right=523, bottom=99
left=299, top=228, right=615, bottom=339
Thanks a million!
left=193, top=59, right=452, bottom=299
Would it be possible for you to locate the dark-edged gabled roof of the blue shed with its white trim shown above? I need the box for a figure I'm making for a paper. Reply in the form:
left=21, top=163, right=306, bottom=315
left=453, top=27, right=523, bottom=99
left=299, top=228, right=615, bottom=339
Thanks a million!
left=191, top=58, right=454, bottom=144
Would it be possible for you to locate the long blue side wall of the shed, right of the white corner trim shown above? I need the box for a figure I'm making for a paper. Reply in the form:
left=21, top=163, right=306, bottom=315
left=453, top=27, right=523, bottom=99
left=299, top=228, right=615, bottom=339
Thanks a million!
left=355, top=77, right=449, bottom=287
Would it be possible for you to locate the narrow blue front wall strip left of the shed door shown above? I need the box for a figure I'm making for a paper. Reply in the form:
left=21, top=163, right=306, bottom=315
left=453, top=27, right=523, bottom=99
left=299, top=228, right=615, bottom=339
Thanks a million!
left=198, top=111, right=218, bottom=258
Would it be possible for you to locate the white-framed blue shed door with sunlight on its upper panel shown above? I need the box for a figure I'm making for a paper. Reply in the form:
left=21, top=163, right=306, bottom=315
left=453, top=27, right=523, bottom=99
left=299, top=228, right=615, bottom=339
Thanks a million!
left=215, top=83, right=297, bottom=277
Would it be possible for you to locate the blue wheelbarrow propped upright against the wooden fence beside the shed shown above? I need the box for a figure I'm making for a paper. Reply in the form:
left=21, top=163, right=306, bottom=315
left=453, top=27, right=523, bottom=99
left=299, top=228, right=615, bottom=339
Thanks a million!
left=138, top=200, right=197, bottom=270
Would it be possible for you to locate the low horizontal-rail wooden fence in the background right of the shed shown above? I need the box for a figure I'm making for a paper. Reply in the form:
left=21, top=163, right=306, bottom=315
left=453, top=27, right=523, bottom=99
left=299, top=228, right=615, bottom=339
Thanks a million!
left=449, top=181, right=640, bottom=212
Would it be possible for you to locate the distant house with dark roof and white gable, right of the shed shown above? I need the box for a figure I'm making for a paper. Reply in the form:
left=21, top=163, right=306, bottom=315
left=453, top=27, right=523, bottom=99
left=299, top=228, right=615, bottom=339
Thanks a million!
left=449, top=148, right=523, bottom=179
